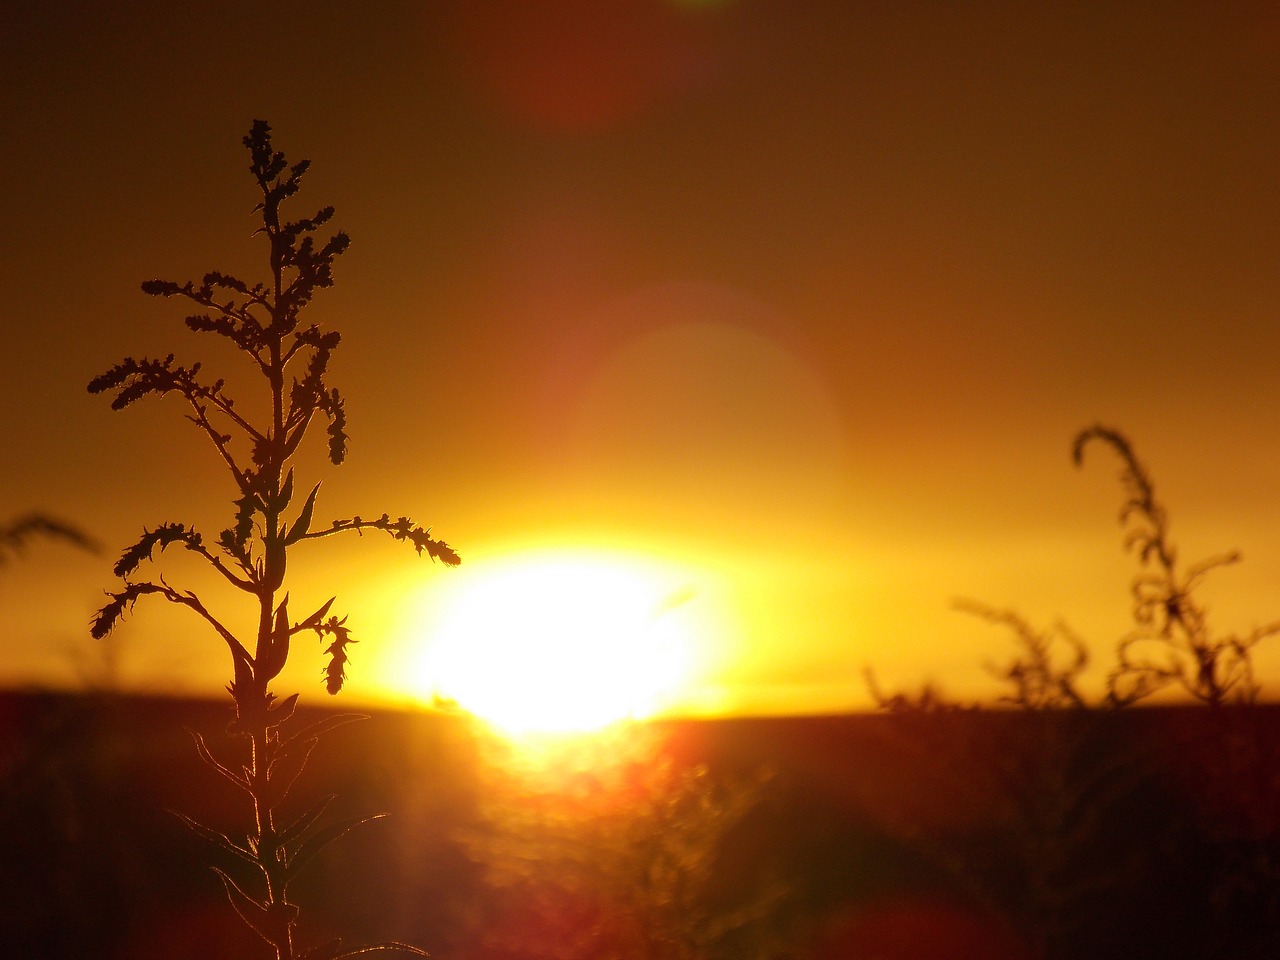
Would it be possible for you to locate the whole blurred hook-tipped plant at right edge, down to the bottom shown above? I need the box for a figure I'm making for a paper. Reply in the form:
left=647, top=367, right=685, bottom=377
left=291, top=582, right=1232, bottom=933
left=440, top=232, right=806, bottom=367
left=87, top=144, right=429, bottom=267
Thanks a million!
left=1073, top=426, right=1280, bottom=957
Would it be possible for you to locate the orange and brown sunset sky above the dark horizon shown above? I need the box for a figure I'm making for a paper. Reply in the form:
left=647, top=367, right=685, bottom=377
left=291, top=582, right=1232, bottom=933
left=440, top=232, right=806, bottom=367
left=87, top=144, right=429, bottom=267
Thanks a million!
left=0, top=0, right=1280, bottom=713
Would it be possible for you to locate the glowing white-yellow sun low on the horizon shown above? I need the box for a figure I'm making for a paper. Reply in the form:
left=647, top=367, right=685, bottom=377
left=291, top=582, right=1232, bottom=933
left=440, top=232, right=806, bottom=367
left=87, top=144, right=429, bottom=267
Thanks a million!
left=407, top=552, right=696, bottom=733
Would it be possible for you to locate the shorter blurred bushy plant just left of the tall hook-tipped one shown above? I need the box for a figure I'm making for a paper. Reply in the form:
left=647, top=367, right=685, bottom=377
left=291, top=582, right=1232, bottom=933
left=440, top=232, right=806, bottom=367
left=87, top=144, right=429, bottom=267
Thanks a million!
left=868, top=600, right=1139, bottom=959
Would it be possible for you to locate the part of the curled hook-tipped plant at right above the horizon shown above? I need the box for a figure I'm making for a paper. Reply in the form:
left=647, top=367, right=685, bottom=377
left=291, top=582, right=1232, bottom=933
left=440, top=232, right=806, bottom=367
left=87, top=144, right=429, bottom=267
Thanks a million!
left=1071, top=426, right=1280, bottom=707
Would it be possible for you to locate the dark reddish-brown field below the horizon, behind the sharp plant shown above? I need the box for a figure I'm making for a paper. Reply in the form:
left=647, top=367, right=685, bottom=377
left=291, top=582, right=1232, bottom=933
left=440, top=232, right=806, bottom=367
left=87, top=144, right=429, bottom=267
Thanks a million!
left=0, top=694, right=1280, bottom=960
